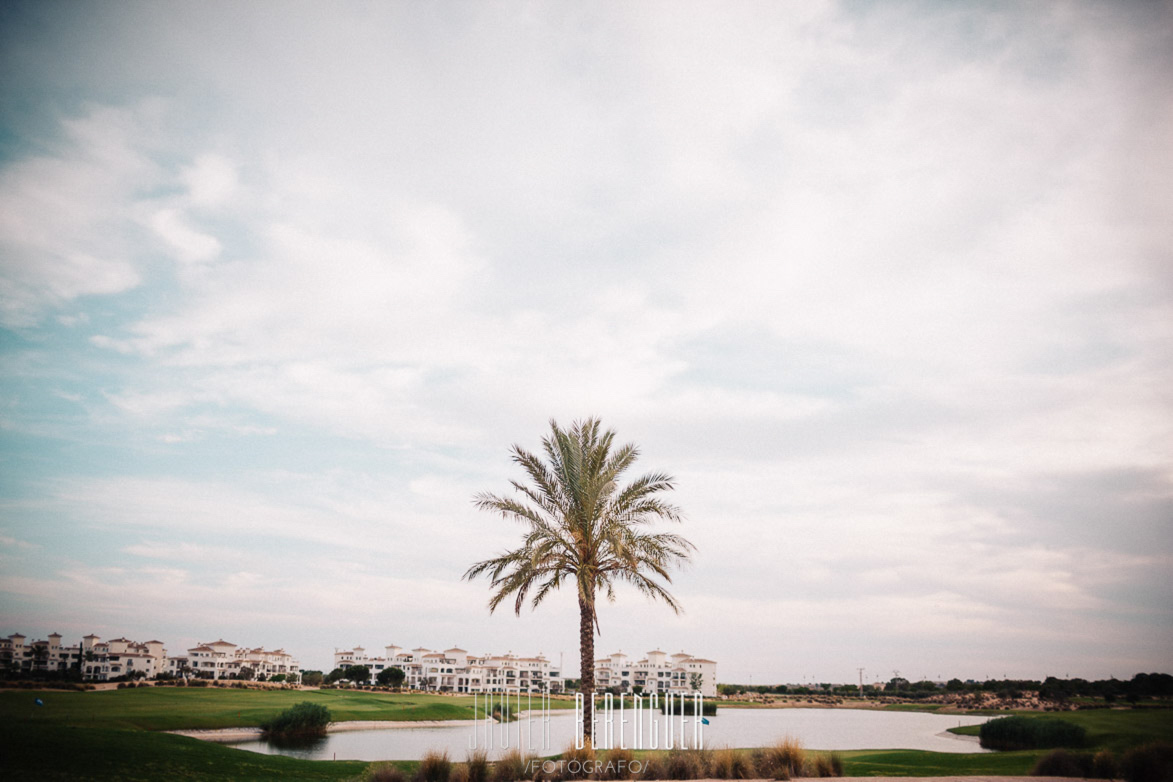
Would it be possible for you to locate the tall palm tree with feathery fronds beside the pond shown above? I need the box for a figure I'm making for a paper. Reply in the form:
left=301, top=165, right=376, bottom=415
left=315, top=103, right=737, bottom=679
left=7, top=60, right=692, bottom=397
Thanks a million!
left=465, top=419, right=694, bottom=735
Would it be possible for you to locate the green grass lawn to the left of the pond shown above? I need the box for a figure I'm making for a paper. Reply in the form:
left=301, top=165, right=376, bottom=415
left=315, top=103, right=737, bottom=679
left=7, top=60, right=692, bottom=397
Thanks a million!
left=0, top=687, right=574, bottom=782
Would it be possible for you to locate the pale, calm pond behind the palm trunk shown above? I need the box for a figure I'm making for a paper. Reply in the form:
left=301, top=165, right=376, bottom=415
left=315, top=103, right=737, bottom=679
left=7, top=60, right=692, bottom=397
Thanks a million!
left=221, top=708, right=988, bottom=761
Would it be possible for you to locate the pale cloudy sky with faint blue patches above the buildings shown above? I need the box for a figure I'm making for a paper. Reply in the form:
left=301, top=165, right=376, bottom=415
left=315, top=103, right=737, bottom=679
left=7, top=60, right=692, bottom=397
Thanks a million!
left=0, top=0, right=1173, bottom=684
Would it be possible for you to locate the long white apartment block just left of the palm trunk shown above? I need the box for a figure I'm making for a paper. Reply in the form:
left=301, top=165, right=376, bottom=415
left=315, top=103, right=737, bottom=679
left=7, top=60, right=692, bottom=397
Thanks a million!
left=334, top=645, right=565, bottom=694
